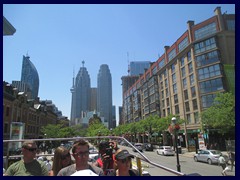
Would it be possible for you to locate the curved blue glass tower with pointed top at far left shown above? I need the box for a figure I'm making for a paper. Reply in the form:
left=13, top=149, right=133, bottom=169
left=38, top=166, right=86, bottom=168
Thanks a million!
left=21, top=55, right=39, bottom=99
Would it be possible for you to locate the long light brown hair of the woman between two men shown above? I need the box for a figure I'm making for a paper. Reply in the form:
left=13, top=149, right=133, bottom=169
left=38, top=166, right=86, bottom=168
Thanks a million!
left=52, top=146, right=72, bottom=176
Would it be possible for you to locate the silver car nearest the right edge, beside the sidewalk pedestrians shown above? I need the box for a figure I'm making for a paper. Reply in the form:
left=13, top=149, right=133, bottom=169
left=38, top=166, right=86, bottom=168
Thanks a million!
left=193, top=150, right=221, bottom=164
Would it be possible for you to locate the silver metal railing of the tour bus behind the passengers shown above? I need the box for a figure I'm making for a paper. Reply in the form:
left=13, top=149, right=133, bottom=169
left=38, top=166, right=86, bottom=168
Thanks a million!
left=3, top=136, right=185, bottom=176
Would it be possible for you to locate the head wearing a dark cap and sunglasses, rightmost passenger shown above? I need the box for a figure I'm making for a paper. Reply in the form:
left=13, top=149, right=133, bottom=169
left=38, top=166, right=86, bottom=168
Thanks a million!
left=115, top=149, right=134, bottom=171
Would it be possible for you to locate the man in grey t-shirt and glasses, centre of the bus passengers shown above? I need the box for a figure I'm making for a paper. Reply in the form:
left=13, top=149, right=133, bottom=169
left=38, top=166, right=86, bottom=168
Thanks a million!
left=57, top=139, right=103, bottom=176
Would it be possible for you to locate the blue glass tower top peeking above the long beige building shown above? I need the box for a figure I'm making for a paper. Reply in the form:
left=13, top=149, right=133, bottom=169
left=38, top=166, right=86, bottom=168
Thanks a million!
left=130, top=61, right=151, bottom=76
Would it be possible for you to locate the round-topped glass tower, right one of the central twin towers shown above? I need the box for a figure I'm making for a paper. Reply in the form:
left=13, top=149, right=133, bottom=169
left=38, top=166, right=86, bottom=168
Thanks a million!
left=97, top=64, right=112, bottom=128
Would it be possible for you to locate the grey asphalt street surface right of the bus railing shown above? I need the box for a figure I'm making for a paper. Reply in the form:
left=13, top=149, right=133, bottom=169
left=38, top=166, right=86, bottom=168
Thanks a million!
left=121, top=146, right=235, bottom=176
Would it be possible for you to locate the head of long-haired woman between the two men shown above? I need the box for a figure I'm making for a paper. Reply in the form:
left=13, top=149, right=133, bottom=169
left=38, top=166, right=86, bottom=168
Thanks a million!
left=52, top=146, right=72, bottom=176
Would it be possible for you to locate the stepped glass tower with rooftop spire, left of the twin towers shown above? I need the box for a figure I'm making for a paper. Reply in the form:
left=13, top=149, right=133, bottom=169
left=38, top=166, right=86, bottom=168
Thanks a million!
left=70, top=61, right=91, bottom=125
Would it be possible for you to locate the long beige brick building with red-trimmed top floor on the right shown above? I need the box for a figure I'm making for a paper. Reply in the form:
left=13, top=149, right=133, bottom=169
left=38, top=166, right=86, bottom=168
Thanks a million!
left=123, top=7, right=235, bottom=149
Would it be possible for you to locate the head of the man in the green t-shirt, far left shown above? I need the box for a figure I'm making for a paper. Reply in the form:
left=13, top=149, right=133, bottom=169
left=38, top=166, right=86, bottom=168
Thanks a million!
left=22, top=140, right=37, bottom=161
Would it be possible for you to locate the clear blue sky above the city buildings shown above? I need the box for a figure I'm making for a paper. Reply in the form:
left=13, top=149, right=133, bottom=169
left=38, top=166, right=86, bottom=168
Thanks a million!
left=3, top=4, right=235, bottom=125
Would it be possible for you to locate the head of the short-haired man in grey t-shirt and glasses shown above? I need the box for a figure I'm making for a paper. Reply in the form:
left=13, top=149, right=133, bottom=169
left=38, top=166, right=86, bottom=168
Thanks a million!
left=72, top=139, right=89, bottom=166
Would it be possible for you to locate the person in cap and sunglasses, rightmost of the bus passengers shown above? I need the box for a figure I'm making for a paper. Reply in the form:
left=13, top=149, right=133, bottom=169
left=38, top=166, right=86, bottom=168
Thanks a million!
left=109, top=149, right=139, bottom=176
